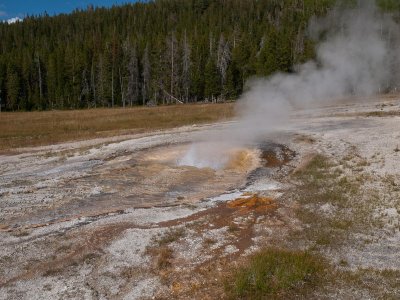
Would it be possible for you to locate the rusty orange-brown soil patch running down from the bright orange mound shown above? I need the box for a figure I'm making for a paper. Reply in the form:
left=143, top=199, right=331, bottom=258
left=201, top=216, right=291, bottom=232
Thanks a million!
left=148, top=194, right=279, bottom=299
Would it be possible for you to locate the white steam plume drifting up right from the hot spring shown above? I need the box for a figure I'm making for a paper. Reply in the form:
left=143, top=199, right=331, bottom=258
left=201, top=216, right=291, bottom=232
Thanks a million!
left=179, top=0, right=400, bottom=168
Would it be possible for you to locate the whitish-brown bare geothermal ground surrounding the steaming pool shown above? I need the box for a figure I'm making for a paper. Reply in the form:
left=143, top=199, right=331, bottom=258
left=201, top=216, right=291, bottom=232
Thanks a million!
left=0, top=95, right=400, bottom=299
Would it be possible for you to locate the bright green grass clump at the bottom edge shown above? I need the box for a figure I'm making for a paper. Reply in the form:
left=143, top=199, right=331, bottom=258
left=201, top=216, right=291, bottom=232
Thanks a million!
left=225, top=249, right=326, bottom=299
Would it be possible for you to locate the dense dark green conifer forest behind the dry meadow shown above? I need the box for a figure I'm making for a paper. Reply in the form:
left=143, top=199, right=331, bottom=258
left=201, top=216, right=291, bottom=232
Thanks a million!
left=0, top=0, right=397, bottom=110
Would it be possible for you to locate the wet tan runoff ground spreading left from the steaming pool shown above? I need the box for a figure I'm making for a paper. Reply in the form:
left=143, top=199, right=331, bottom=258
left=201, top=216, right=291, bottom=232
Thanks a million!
left=1, top=144, right=278, bottom=231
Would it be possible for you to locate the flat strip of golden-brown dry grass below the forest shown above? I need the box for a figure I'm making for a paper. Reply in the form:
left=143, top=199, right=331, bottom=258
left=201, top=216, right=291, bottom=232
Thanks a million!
left=0, top=103, right=234, bottom=151
